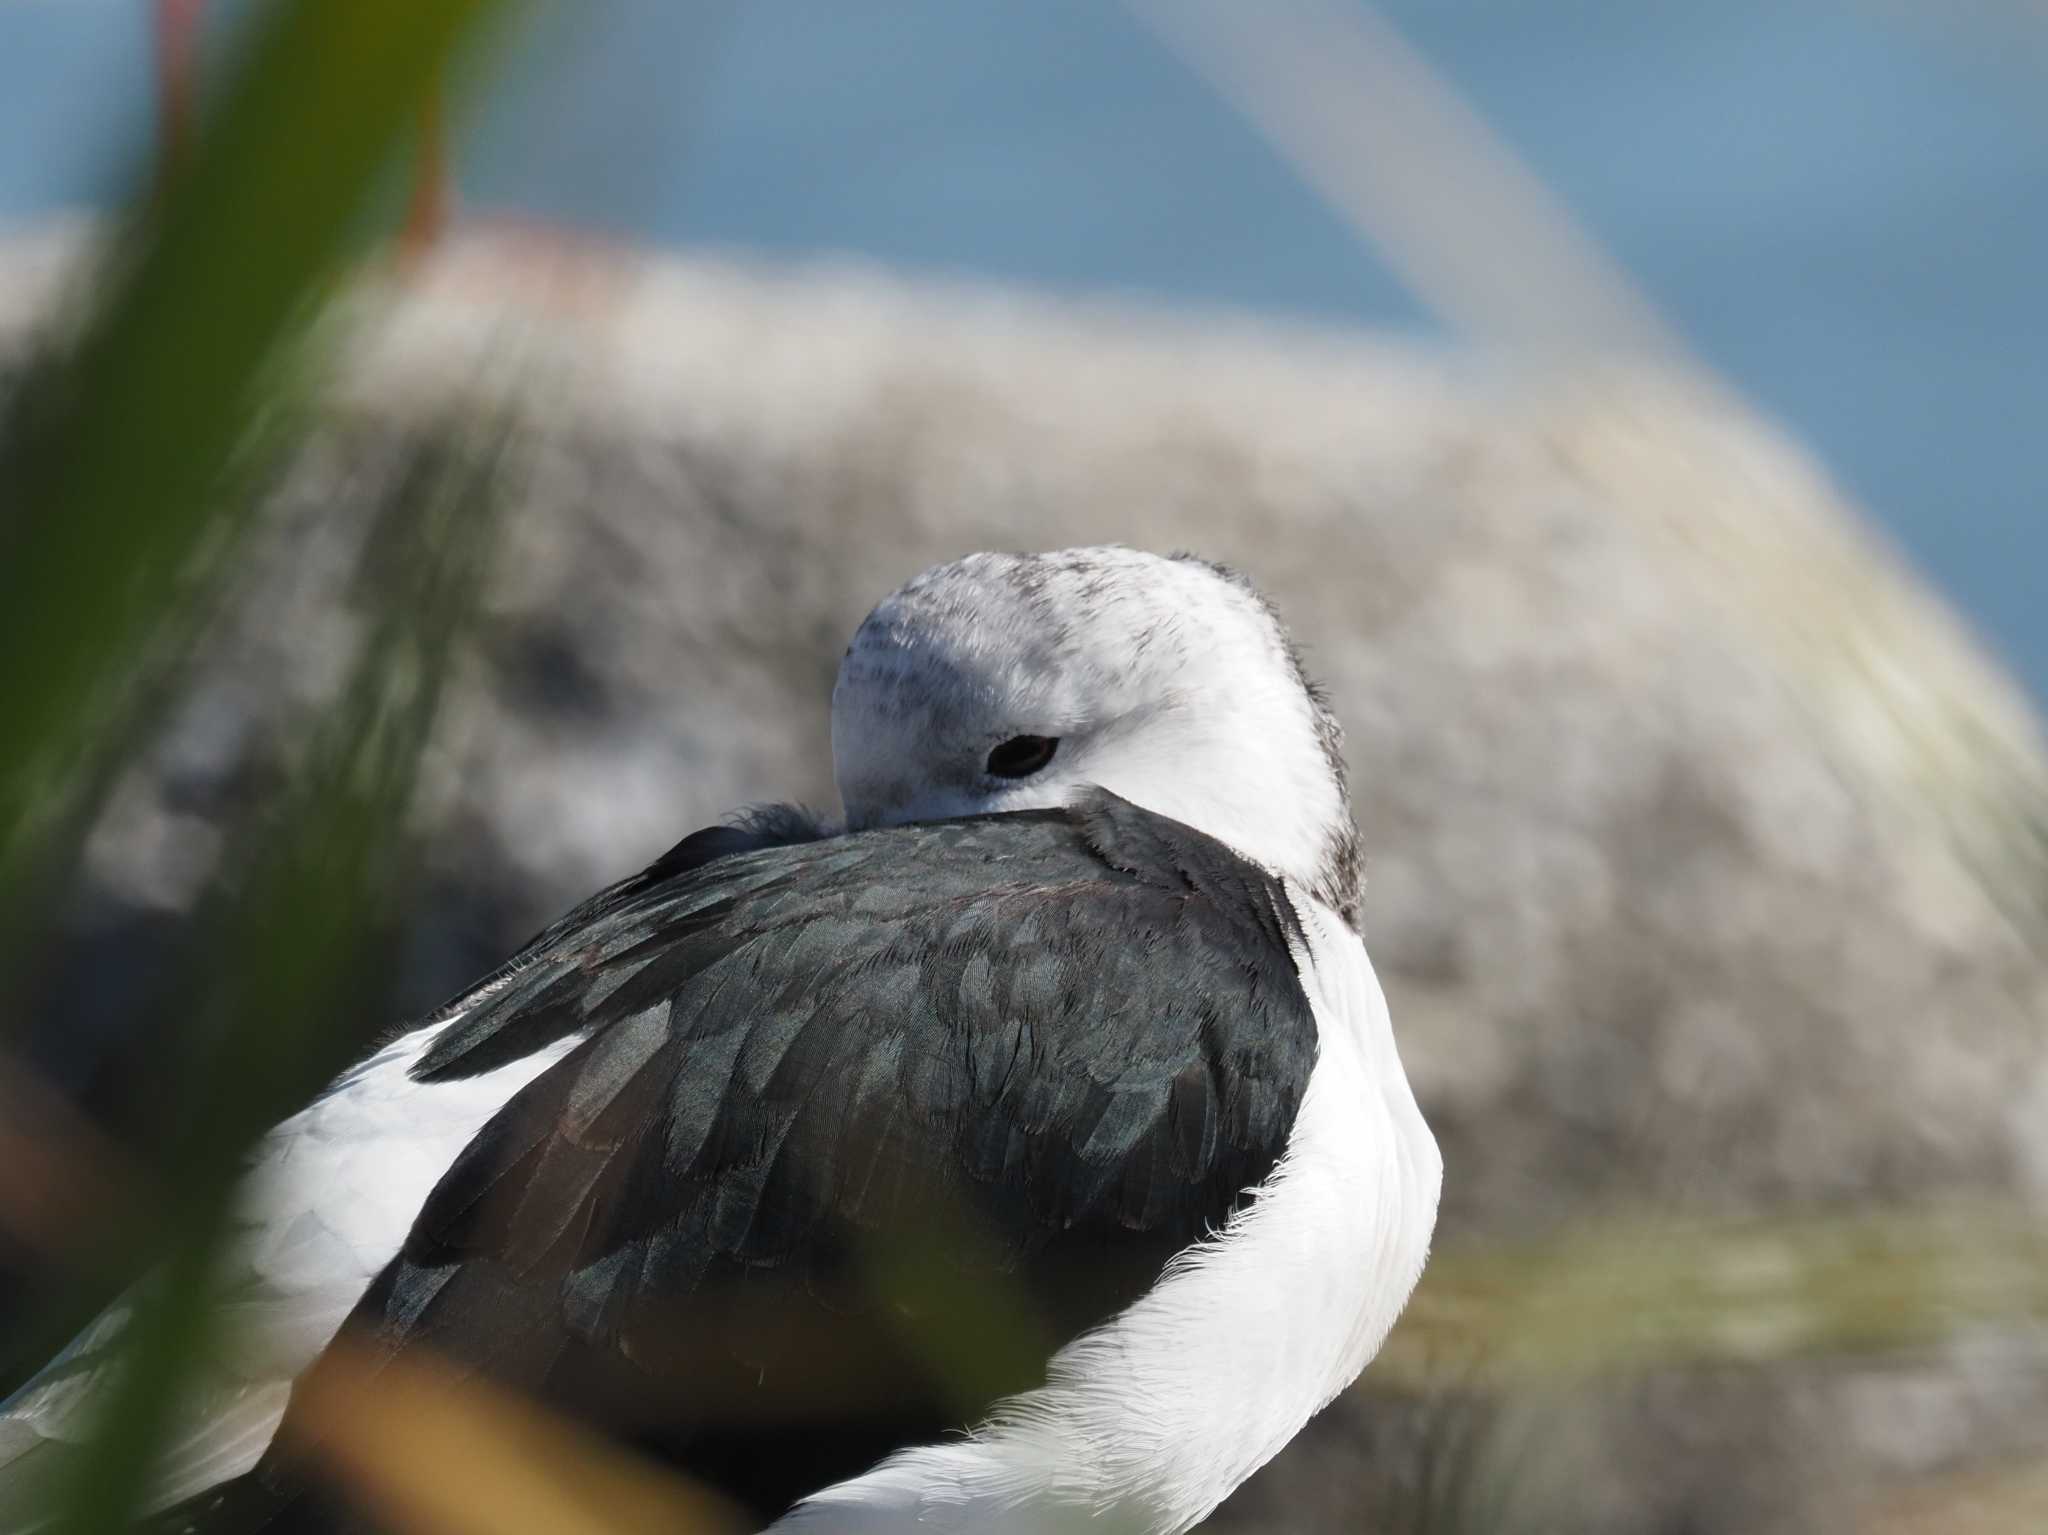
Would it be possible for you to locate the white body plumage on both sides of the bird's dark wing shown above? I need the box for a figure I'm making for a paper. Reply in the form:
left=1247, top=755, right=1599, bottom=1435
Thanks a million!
left=0, top=892, right=1442, bottom=1535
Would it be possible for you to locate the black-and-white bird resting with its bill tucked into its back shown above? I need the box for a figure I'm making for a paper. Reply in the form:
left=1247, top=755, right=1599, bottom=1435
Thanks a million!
left=0, top=546, right=1442, bottom=1535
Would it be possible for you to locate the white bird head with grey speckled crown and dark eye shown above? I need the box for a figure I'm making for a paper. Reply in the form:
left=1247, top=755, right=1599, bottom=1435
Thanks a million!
left=831, top=549, right=1358, bottom=921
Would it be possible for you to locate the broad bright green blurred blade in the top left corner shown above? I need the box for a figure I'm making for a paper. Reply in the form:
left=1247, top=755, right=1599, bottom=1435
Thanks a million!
left=0, top=0, right=502, bottom=900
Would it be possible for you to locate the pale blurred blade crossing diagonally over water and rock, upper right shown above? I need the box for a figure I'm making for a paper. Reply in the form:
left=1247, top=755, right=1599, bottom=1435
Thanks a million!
left=1124, top=0, right=2048, bottom=954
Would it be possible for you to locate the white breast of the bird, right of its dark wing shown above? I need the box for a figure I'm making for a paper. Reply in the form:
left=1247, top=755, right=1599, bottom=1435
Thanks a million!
left=774, top=892, right=1442, bottom=1535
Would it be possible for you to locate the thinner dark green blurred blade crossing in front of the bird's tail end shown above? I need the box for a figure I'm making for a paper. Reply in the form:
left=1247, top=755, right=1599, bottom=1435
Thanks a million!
left=48, top=409, right=516, bottom=1535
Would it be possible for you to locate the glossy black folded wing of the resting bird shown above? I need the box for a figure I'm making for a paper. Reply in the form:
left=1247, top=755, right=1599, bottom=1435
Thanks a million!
left=211, top=794, right=1315, bottom=1527
